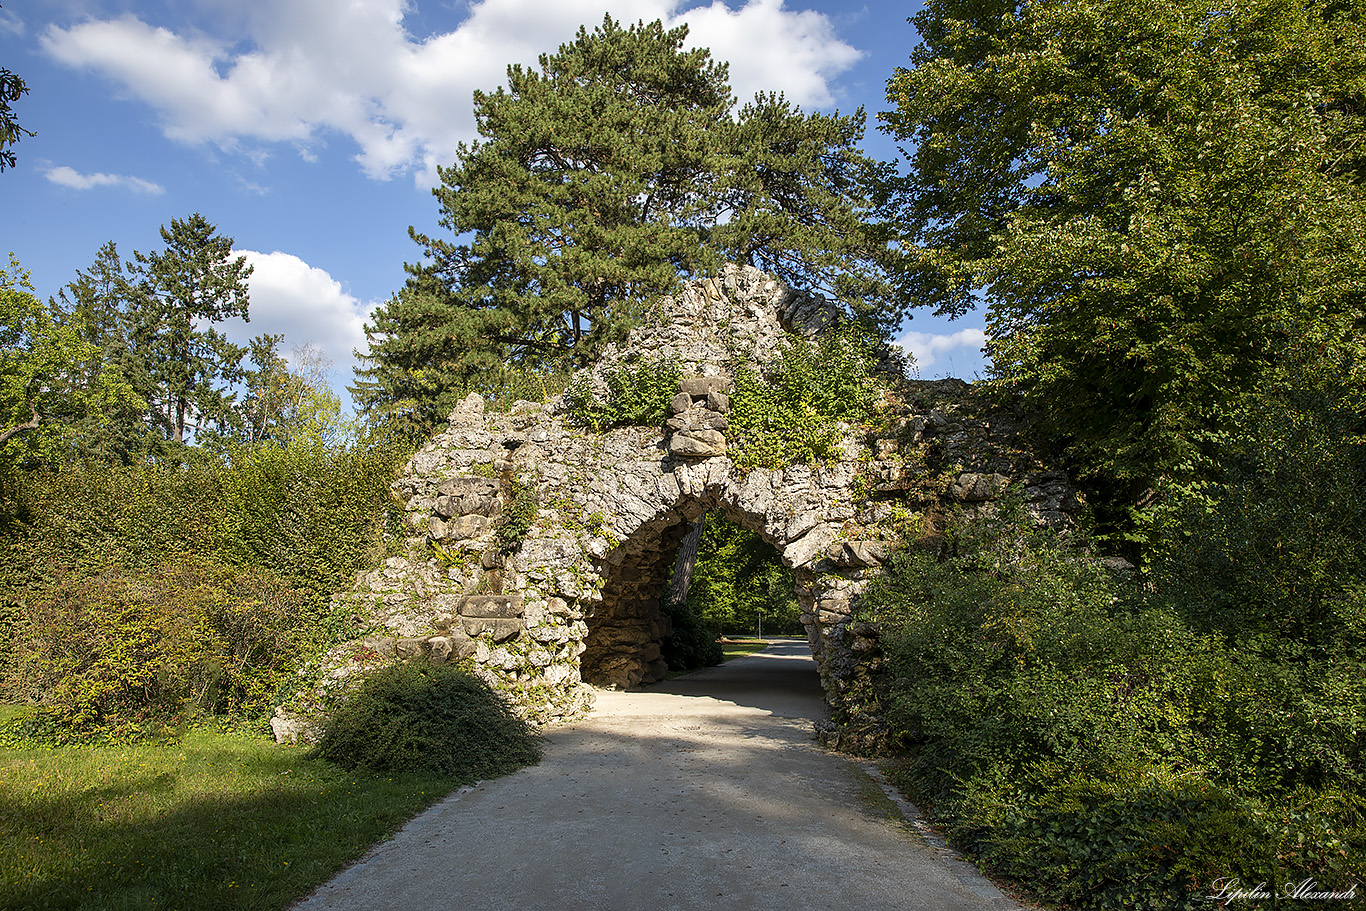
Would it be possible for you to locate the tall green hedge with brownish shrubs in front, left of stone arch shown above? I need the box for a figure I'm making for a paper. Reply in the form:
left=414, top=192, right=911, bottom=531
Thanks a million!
left=0, top=438, right=406, bottom=736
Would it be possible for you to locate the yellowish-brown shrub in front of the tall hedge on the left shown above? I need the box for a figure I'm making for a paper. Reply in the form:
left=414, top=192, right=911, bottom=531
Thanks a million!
left=7, top=557, right=301, bottom=740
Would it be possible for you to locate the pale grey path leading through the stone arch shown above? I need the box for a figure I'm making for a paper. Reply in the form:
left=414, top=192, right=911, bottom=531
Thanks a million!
left=295, top=641, right=1020, bottom=911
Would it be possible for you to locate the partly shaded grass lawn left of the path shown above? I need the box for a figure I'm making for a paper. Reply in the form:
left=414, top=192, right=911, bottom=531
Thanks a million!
left=0, top=731, right=455, bottom=911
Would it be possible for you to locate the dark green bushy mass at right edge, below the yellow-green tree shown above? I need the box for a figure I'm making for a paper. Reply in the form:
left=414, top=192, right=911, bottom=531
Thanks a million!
left=1153, top=346, right=1366, bottom=658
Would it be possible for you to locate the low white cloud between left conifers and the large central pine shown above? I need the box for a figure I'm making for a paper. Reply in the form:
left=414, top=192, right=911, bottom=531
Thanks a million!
left=225, top=250, right=374, bottom=402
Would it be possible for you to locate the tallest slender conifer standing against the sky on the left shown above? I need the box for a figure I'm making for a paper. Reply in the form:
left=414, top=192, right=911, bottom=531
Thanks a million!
left=131, top=213, right=251, bottom=444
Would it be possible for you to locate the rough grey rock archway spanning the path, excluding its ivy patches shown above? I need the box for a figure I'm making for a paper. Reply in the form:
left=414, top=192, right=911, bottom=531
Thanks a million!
left=272, top=266, right=1076, bottom=750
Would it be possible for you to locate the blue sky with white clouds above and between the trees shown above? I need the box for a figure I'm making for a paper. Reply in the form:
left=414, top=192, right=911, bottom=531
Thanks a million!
left=0, top=0, right=985, bottom=401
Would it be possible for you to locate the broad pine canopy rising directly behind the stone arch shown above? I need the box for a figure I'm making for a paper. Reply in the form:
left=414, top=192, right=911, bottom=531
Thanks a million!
left=355, top=16, right=896, bottom=437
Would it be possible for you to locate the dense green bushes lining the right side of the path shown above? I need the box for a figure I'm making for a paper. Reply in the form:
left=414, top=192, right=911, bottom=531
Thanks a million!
left=865, top=494, right=1366, bottom=908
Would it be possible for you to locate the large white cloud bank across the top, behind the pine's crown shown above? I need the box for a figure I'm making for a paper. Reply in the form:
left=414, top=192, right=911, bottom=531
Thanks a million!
left=41, top=0, right=859, bottom=183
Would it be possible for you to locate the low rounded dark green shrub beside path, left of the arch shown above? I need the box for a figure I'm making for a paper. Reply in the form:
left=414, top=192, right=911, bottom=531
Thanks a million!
left=318, top=661, right=541, bottom=783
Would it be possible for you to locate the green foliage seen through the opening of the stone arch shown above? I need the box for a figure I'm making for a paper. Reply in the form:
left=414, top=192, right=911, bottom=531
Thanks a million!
left=687, top=512, right=803, bottom=635
